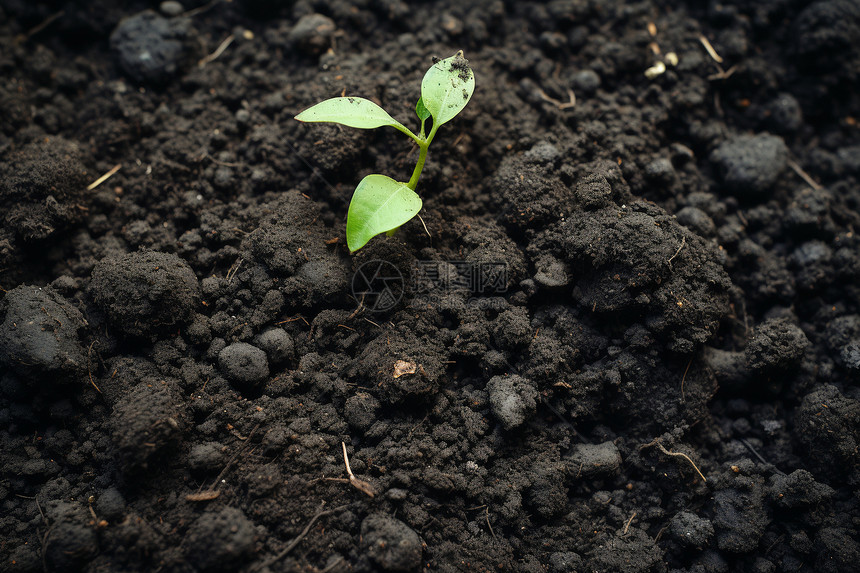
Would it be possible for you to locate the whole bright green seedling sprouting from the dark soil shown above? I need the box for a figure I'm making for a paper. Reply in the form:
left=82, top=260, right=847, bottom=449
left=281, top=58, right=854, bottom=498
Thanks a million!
left=296, top=51, right=475, bottom=252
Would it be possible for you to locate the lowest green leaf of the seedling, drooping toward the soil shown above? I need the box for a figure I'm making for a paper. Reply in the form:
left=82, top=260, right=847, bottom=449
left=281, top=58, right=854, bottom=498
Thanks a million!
left=346, top=174, right=421, bottom=253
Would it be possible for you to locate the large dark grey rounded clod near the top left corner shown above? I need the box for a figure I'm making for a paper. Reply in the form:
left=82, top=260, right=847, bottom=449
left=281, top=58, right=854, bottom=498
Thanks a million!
left=110, top=10, right=193, bottom=85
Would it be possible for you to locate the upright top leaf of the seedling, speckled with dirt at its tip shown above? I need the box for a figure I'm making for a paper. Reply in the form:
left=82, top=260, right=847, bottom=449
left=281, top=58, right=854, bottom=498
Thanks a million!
left=416, top=50, right=475, bottom=128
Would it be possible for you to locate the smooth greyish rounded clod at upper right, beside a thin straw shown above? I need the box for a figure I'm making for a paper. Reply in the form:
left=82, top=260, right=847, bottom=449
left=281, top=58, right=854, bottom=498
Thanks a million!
left=711, top=133, right=788, bottom=199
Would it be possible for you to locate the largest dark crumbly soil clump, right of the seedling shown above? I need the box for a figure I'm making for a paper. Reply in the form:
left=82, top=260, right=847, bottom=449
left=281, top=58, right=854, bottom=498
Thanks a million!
left=530, top=201, right=730, bottom=352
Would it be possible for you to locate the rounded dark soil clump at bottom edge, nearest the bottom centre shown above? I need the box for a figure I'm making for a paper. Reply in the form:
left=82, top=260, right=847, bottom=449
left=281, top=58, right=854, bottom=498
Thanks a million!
left=361, top=514, right=423, bottom=571
